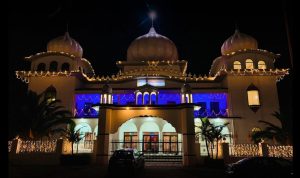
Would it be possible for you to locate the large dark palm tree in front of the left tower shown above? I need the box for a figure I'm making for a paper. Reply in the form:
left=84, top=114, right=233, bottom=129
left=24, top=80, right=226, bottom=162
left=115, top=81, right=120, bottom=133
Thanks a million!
left=11, top=91, right=73, bottom=139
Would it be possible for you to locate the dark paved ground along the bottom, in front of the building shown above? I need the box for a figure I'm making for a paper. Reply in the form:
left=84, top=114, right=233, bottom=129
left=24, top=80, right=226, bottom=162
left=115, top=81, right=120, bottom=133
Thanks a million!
left=9, top=165, right=224, bottom=178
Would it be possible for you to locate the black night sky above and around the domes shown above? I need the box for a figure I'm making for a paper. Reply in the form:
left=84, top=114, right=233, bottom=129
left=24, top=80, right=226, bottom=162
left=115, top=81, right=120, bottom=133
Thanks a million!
left=8, top=0, right=292, bottom=118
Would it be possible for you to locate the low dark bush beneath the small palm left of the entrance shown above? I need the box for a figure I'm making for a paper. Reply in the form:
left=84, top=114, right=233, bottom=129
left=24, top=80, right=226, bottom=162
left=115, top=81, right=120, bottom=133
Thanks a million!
left=60, top=153, right=92, bottom=165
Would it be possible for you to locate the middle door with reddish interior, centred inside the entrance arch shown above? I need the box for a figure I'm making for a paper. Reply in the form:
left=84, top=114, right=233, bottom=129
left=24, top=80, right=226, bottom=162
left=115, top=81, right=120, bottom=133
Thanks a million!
left=143, top=132, right=159, bottom=153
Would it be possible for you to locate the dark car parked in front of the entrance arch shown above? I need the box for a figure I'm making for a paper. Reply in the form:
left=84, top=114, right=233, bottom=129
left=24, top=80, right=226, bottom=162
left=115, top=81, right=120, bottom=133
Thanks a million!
left=108, top=149, right=145, bottom=173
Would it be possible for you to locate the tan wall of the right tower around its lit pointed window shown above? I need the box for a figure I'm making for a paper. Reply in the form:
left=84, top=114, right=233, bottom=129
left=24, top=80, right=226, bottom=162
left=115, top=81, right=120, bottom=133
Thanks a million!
left=224, top=76, right=279, bottom=143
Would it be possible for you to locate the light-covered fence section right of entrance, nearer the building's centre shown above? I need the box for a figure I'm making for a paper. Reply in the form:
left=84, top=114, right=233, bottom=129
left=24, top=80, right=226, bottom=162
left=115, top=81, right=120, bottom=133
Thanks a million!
left=229, top=144, right=262, bottom=157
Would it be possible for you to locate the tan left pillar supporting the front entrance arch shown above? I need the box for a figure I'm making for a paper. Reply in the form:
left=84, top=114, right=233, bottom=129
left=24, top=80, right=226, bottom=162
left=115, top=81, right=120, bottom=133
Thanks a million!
left=96, top=108, right=112, bottom=165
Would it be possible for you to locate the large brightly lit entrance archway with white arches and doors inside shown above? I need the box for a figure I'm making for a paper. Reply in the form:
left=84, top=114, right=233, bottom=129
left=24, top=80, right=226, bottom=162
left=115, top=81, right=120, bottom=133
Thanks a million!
left=111, top=116, right=182, bottom=155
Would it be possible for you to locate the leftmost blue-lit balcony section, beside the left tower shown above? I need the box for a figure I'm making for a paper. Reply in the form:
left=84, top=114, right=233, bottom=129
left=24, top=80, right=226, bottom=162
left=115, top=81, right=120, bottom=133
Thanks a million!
left=75, top=94, right=100, bottom=118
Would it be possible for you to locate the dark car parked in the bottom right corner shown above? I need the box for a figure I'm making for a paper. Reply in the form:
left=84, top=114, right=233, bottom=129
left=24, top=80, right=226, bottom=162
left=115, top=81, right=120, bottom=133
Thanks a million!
left=226, top=157, right=293, bottom=178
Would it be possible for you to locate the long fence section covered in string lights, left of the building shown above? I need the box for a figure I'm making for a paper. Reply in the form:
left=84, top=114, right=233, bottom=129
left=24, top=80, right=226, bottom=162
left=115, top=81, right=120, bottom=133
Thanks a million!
left=16, top=140, right=57, bottom=154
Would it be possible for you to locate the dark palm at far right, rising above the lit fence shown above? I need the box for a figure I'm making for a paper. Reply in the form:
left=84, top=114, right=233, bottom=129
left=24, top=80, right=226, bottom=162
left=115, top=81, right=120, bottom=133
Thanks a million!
left=251, top=111, right=292, bottom=145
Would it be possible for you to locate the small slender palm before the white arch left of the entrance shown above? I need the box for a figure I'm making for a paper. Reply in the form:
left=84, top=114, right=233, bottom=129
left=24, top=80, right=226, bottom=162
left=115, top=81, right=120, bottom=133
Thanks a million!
left=65, top=122, right=84, bottom=155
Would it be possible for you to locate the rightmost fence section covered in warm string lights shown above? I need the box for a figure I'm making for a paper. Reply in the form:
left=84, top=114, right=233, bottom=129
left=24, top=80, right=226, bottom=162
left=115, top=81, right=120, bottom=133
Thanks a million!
left=267, top=145, right=293, bottom=158
